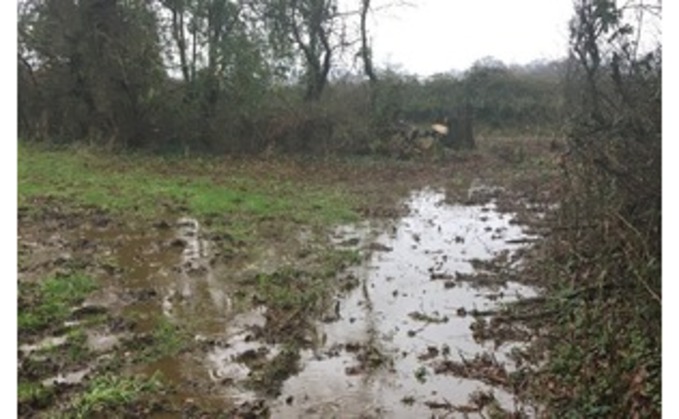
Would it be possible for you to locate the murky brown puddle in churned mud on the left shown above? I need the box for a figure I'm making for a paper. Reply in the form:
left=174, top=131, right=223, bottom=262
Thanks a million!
left=19, top=213, right=244, bottom=409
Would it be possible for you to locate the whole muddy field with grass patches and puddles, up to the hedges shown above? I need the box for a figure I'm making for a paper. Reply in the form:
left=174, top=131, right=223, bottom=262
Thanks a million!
left=18, top=140, right=555, bottom=418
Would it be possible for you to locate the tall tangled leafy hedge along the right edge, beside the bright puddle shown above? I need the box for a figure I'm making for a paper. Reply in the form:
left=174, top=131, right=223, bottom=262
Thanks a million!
left=536, top=0, right=662, bottom=418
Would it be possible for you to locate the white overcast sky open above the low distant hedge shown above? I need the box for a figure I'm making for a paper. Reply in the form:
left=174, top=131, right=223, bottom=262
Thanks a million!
left=370, top=0, right=573, bottom=76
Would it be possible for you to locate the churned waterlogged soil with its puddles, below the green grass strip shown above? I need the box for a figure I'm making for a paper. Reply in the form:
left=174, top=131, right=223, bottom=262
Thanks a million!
left=18, top=139, right=554, bottom=418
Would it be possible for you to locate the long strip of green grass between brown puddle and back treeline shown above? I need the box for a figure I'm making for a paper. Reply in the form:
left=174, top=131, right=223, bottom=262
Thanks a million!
left=18, top=144, right=356, bottom=224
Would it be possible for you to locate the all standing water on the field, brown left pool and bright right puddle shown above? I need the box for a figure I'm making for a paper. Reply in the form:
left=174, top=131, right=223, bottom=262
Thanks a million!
left=33, top=189, right=536, bottom=418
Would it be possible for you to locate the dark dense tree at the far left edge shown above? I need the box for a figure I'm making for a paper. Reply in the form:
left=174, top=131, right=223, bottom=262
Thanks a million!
left=18, top=0, right=162, bottom=146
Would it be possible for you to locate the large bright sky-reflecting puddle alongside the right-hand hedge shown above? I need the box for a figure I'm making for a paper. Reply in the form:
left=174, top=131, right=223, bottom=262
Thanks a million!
left=273, top=190, right=535, bottom=418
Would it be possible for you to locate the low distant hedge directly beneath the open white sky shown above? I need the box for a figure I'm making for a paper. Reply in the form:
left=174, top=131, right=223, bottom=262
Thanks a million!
left=376, top=58, right=565, bottom=132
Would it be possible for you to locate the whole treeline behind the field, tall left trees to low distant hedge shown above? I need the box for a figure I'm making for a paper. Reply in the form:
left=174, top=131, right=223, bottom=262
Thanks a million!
left=17, top=0, right=564, bottom=153
